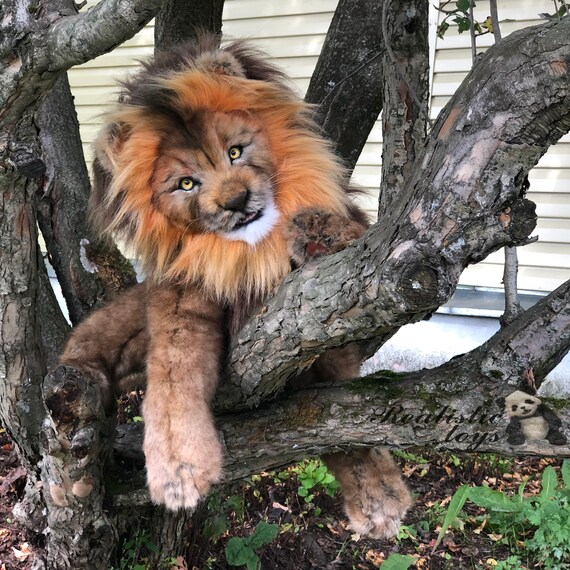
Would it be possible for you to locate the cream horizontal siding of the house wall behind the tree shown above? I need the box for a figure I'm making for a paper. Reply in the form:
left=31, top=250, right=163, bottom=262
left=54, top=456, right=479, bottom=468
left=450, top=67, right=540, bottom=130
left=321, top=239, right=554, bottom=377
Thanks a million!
left=69, top=0, right=570, bottom=291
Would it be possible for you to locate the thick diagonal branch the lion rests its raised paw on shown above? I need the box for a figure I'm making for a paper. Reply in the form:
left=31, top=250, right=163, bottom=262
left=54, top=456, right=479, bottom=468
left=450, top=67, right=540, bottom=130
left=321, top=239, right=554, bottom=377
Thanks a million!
left=222, top=19, right=570, bottom=405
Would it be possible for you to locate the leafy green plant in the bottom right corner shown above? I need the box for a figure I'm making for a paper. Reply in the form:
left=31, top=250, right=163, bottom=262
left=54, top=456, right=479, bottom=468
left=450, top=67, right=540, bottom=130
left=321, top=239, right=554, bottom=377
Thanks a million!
left=434, top=461, right=570, bottom=570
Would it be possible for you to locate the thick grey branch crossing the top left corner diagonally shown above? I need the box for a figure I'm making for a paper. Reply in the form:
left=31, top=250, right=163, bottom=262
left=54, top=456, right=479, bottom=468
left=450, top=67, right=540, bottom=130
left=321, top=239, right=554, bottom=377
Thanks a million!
left=0, top=0, right=162, bottom=130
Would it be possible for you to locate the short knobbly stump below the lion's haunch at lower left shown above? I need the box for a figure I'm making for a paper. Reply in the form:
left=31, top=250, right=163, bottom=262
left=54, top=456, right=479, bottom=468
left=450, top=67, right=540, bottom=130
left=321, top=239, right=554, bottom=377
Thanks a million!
left=41, top=367, right=118, bottom=570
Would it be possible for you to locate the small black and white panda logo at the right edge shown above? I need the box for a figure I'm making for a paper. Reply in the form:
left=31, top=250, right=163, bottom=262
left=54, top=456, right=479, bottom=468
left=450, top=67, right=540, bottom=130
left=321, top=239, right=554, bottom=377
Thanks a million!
left=503, top=390, right=567, bottom=445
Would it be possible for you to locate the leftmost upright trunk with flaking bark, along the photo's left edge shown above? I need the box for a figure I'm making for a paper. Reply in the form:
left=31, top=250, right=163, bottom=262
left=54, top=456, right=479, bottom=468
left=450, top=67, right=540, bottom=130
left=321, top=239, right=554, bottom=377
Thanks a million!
left=0, top=165, right=45, bottom=462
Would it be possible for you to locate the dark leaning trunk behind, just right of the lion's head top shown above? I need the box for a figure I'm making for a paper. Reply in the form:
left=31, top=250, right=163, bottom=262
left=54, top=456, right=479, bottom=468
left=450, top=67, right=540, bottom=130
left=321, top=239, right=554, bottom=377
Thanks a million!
left=305, top=0, right=384, bottom=171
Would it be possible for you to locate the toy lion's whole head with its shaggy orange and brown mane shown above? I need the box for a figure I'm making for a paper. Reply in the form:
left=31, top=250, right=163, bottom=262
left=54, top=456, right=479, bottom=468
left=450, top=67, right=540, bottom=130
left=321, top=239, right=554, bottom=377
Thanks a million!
left=91, top=32, right=362, bottom=304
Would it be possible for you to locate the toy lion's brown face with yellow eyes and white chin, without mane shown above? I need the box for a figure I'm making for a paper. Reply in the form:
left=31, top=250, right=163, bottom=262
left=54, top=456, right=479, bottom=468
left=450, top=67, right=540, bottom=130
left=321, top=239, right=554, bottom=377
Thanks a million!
left=151, top=111, right=278, bottom=245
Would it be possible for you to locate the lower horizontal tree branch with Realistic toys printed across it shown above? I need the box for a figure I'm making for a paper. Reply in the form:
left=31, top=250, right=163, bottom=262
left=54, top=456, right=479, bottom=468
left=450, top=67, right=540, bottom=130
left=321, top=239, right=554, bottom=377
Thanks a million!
left=111, top=281, right=570, bottom=502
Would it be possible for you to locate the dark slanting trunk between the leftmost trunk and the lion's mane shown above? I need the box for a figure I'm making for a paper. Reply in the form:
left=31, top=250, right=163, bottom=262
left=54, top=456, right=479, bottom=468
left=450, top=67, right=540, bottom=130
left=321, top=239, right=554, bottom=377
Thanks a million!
left=38, top=74, right=136, bottom=324
